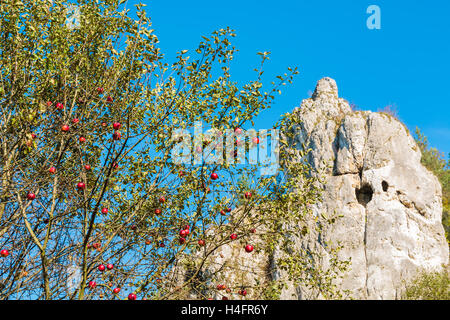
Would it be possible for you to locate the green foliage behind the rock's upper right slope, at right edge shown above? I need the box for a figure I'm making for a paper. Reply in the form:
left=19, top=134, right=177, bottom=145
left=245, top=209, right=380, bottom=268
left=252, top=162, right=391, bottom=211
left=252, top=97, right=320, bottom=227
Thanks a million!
left=415, top=128, right=450, bottom=244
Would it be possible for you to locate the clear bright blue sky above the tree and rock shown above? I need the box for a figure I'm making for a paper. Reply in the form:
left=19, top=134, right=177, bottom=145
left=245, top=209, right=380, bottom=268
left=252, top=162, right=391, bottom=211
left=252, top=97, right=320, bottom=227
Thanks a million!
left=128, top=0, right=450, bottom=157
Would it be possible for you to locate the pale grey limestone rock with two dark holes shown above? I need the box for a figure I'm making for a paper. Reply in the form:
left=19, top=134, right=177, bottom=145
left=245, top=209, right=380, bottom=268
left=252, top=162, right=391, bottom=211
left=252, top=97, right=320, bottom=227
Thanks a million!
left=282, top=78, right=449, bottom=299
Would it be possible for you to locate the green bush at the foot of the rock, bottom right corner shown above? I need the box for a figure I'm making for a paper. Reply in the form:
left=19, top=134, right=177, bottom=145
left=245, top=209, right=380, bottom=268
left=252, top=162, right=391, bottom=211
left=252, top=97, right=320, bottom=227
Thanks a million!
left=403, top=270, right=450, bottom=300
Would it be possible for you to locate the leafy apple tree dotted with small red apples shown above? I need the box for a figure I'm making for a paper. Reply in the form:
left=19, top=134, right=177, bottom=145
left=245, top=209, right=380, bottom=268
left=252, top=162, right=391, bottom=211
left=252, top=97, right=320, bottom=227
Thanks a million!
left=0, top=0, right=348, bottom=300
